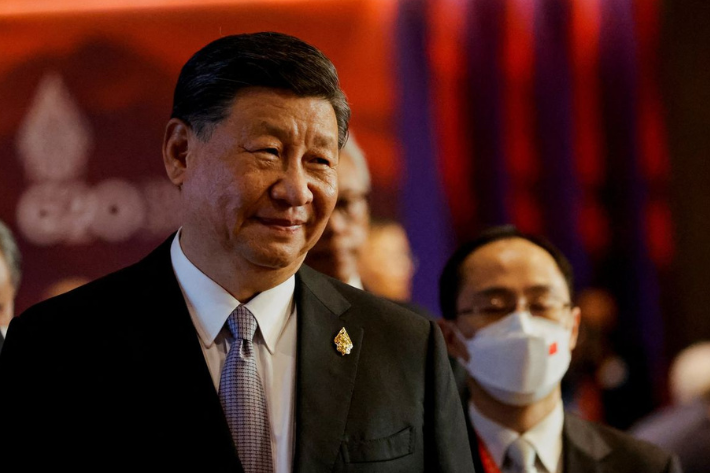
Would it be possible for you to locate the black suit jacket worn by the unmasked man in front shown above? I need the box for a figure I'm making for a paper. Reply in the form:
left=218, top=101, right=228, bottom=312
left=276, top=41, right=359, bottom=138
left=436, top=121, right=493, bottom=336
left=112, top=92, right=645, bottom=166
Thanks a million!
left=0, top=239, right=473, bottom=473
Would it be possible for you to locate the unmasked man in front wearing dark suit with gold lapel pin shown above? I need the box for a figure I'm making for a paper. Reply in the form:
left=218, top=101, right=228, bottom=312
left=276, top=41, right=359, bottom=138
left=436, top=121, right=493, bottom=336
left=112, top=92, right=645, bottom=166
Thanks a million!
left=0, top=33, right=473, bottom=473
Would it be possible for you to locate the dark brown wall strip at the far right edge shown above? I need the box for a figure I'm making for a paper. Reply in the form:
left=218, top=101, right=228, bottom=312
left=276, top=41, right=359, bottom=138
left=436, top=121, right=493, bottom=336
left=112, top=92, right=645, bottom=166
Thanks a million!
left=660, top=0, right=710, bottom=354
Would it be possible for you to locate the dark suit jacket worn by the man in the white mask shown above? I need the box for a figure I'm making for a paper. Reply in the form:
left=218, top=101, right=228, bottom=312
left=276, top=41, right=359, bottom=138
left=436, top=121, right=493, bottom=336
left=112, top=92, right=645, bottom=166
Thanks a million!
left=452, top=362, right=681, bottom=473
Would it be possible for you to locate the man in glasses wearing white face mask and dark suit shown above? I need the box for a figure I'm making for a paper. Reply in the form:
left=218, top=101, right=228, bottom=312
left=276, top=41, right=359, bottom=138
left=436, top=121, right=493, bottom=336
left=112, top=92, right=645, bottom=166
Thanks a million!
left=439, top=226, right=680, bottom=473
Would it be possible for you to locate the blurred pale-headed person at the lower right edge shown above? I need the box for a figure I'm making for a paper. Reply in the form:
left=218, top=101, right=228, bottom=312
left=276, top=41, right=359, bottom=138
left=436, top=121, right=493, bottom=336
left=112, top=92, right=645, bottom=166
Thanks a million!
left=629, top=341, right=710, bottom=473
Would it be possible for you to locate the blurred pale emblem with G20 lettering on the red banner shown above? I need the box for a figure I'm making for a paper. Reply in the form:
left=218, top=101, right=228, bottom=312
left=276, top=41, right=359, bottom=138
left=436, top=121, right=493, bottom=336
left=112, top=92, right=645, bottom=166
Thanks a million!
left=17, top=72, right=180, bottom=246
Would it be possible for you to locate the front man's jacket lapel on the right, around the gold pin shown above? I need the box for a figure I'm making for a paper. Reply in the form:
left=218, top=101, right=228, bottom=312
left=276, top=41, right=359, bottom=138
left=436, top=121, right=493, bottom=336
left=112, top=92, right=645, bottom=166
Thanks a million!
left=293, top=266, right=363, bottom=473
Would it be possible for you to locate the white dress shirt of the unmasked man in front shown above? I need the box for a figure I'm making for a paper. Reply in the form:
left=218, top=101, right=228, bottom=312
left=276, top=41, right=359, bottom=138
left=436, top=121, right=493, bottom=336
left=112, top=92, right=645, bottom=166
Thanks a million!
left=170, top=231, right=297, bottom=473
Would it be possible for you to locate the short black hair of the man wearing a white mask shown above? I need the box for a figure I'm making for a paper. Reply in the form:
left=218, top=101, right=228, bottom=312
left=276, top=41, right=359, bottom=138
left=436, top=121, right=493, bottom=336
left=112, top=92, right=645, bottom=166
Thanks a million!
left=439, top=225, right=574, bottom=319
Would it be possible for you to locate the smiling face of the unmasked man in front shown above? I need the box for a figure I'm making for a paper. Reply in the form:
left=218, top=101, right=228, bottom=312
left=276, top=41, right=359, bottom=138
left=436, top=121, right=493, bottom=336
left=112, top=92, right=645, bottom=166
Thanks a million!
left=173, top=87, right=338, bottom=272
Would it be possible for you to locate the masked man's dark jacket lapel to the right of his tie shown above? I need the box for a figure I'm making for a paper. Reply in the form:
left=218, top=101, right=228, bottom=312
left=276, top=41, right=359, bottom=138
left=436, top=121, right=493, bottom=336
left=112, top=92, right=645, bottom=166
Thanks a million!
left=562, top=413, right=611, bottom=473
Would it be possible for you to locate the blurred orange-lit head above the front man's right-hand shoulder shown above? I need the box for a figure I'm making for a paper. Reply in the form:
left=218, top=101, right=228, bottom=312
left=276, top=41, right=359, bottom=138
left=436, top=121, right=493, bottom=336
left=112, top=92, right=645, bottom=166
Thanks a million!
left=359, top=218, right=415, bottom=301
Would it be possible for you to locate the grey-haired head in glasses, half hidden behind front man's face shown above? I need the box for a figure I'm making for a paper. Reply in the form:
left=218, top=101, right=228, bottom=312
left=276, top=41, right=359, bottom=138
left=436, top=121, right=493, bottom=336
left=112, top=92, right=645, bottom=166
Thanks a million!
left=306, top=132, right=370, bottom=288
